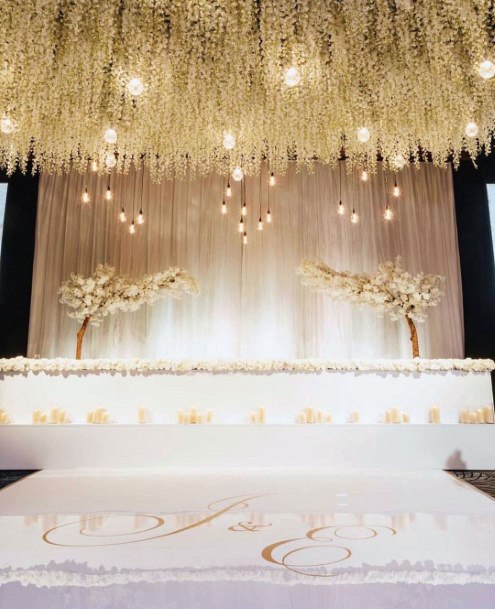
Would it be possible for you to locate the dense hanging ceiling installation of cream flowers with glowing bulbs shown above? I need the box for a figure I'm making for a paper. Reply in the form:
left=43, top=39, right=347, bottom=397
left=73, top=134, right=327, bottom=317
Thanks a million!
left=0, top=0, right=495, bottom=179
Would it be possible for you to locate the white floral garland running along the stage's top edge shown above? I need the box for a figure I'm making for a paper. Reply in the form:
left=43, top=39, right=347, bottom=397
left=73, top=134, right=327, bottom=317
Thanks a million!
left=0, top=357, right=495, bottom=374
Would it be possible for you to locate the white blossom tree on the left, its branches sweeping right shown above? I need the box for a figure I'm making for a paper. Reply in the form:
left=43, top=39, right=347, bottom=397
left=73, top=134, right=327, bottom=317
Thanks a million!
left=58, top=264, right=199, bottom=359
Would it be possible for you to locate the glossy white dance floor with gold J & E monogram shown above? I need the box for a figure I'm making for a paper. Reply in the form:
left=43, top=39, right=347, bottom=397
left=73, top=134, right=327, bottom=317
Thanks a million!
left=0, top=469, right=495, bottom=609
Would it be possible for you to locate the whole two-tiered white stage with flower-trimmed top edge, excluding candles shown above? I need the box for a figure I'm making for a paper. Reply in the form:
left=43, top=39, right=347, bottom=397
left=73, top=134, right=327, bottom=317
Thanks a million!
left=0, top=358, right=495, bottom=469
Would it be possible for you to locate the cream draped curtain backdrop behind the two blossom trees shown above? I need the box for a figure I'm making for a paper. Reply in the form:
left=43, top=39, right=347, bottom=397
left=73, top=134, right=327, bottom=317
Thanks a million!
left=29, top=162, right=463, bottom=359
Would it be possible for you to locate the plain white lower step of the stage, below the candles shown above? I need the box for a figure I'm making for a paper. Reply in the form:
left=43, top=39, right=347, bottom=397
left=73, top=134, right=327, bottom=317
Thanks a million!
left=0, top=425, right=495, bottom=470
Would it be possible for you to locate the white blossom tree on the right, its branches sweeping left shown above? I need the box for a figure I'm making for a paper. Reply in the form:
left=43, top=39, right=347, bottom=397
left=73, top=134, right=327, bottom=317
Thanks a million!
left=296, top=256, right=445, bottom=357
